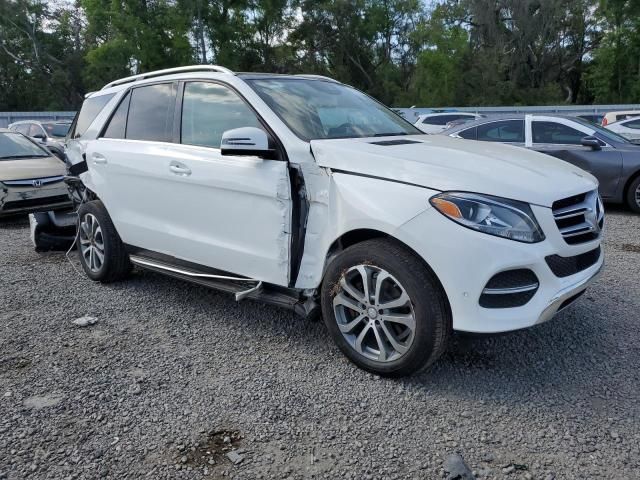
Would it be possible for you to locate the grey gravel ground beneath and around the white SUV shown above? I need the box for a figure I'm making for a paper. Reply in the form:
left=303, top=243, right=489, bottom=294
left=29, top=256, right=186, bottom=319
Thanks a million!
left=0, top=209, right=640, bottom=479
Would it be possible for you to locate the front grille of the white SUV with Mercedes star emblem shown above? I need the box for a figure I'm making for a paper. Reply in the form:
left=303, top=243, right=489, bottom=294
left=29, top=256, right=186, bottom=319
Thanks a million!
left=551, top=190, right=604, bottom=245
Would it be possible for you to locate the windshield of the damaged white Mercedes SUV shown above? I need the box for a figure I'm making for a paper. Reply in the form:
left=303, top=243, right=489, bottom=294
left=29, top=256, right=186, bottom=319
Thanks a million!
left=247, top=78, right=422, bottom=141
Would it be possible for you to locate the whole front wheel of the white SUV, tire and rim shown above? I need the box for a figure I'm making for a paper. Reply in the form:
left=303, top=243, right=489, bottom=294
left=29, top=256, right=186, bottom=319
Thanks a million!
left=322, top=239, right=451, bottom=377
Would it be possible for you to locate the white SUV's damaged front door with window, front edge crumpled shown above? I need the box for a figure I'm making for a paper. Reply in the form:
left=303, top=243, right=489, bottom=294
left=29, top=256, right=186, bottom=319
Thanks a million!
left=162, top=82, right=291, bottom=286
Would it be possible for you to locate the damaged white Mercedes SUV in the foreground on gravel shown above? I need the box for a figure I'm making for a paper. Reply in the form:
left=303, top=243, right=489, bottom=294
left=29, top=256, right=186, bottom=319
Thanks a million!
left=67, top=66, right=603, bottom=376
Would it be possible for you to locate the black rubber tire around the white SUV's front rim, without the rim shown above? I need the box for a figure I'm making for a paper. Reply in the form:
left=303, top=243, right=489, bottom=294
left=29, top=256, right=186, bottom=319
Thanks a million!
left=321, top=239, right=452, bottom=377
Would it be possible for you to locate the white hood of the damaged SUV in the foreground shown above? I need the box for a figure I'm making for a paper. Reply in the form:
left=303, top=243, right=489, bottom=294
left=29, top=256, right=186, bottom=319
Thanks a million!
left=311, top=135, right=598, bottom=207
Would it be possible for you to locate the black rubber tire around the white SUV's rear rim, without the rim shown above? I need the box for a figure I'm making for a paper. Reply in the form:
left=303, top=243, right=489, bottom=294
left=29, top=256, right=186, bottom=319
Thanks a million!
left=77, top=200, right=132, bottom=283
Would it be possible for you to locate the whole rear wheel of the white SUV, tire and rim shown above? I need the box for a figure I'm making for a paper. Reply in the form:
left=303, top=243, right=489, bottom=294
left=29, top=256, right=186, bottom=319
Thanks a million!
left=77, top=200, right=132, bottom=283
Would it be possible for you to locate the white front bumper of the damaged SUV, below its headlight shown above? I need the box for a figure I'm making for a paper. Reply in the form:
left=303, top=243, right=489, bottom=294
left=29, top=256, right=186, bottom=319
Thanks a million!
left=396, top=206, right=604, bottom=333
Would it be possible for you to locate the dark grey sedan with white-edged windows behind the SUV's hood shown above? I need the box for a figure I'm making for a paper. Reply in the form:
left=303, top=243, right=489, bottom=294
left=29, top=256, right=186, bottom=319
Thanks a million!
left=443, top=115, right=640, bottom=213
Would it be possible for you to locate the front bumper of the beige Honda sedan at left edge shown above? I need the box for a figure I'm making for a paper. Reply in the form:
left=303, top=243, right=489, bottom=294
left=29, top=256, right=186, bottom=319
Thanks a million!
left=0, top=181, right=72, bottom=216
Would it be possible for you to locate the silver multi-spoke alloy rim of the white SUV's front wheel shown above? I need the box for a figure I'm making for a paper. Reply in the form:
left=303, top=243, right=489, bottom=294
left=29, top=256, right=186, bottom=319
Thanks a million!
left=333, top=265, right=416, bottom=362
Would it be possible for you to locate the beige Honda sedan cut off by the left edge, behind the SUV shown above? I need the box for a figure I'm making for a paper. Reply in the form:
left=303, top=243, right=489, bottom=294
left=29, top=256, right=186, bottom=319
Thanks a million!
left=0, top=129, right=71, bottom=216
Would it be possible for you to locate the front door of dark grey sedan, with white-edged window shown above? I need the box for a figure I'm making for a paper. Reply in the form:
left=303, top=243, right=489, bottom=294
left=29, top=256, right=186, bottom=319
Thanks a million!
left=530, top=117, right=622, bottom=198
